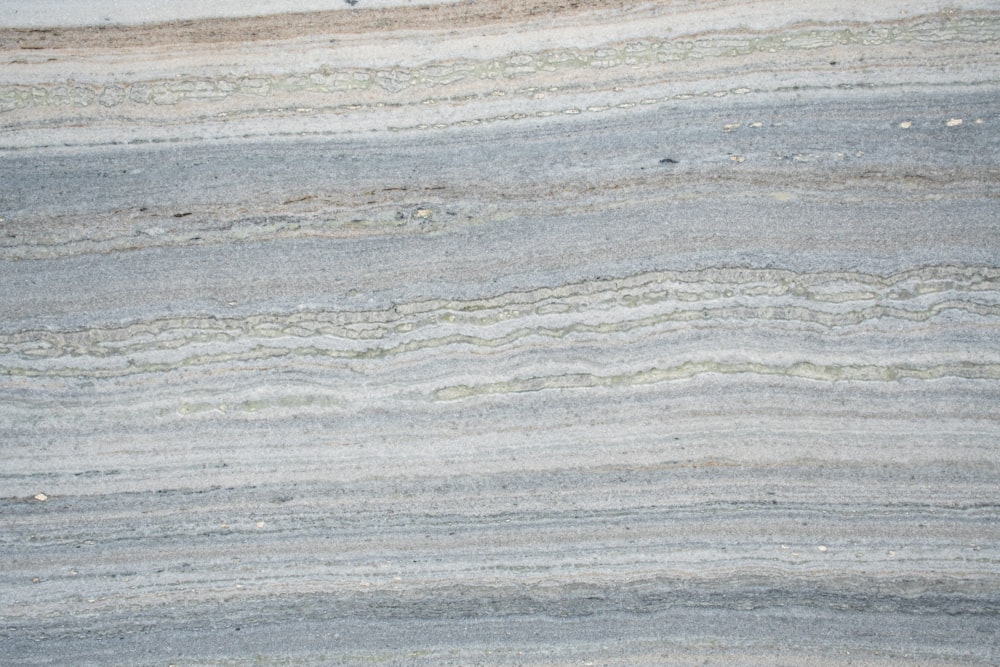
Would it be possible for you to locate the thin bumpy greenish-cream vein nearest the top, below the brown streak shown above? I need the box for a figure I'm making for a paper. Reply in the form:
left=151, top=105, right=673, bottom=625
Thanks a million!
left=0, top=12, right=998, bottom=115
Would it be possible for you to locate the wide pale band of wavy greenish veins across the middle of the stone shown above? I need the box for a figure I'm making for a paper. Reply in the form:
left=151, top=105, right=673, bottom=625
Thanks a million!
left=0, top=266, right=1000, bottom=414
